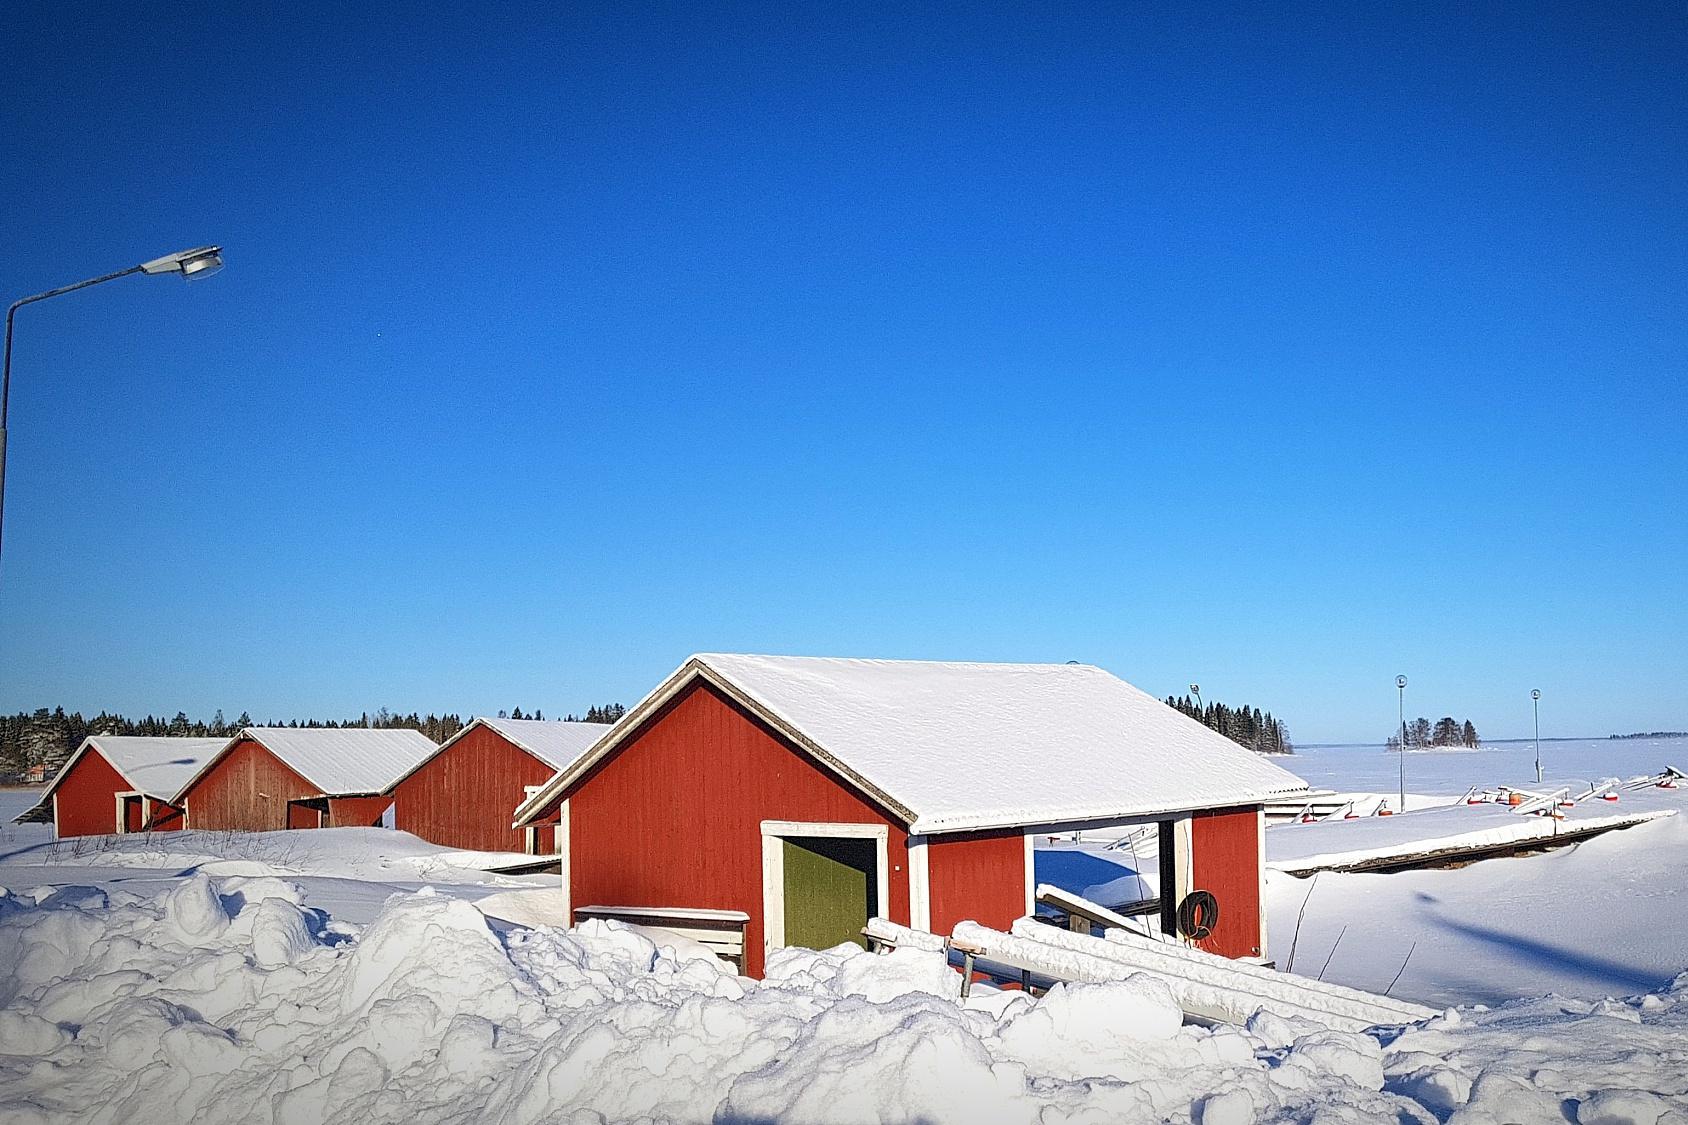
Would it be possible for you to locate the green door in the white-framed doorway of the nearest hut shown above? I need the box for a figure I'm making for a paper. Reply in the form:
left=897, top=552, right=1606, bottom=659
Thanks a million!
left=782, top=836, right=879, bottom=949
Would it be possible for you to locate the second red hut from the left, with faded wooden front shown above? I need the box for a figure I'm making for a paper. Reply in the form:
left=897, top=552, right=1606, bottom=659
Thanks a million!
left=176, top=726, right=436, bottom=831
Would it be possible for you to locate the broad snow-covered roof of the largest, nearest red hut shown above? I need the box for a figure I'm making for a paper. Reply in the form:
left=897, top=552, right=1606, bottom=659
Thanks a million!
left=517, top=654, right=1305, bottom=833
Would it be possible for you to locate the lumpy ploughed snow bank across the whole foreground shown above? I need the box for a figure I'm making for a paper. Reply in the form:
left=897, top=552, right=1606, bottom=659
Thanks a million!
left=0, top=873, right=1688, bottom=1125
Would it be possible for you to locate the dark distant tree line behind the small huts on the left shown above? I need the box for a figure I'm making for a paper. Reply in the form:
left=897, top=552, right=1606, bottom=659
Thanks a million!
left=0, top=703, right=626, bottom=775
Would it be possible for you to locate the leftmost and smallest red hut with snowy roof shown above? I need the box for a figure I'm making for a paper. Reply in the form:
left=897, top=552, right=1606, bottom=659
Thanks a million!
left=17, top=735, right=225, bottom=838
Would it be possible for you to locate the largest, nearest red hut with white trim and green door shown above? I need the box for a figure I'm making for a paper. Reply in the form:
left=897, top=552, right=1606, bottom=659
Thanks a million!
left=517, top=655, right=1305, bottom=975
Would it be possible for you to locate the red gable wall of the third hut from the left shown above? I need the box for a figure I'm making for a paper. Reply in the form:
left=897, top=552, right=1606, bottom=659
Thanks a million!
left=391, top=726, right=557, bottom=851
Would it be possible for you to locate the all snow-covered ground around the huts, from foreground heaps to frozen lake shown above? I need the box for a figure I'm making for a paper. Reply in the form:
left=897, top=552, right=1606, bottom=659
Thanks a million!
left=0, top=726, right=1688, bottom=1125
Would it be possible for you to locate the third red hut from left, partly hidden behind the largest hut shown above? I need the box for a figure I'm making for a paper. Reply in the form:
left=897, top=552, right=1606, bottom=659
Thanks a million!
left=387, top=718, right=609, bottom=855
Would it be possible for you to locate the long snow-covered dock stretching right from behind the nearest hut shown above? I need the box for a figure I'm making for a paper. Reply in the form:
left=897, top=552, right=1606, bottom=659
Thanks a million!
left=1266, top=791, right=1680, bottom=875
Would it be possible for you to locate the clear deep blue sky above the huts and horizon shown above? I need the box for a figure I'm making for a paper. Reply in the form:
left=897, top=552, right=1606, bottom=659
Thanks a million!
left=0, top=3, right=1688, bottom=742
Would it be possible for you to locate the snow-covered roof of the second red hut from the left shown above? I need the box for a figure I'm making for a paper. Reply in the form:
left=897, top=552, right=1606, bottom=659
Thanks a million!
left=176, top=726, right=437, bottom=797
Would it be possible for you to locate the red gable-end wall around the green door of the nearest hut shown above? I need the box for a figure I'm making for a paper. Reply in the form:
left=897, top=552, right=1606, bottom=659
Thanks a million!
left=565, top=682, right=908, bottom=976
